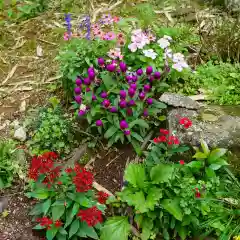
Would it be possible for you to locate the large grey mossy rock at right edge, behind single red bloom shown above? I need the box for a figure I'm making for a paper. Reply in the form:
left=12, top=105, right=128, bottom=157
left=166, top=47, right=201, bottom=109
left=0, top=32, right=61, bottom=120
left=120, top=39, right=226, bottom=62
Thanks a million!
left=168, top=106, right=240, bottom=148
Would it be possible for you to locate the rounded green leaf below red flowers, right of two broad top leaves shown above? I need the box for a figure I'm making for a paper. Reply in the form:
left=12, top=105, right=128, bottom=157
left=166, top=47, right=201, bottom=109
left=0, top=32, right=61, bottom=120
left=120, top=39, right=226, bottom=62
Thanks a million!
left=150, top=163, right=174, bottom=183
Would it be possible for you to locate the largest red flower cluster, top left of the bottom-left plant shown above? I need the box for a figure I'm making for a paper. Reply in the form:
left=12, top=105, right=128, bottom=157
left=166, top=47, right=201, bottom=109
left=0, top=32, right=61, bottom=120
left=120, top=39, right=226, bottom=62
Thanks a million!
left=29, top=152, right=61, bottom=184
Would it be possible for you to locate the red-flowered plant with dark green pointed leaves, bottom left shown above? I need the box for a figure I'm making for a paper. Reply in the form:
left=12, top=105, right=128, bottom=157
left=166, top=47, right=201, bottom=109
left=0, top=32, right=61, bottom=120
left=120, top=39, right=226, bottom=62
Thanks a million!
left=27, top=152, right=108, bottom=240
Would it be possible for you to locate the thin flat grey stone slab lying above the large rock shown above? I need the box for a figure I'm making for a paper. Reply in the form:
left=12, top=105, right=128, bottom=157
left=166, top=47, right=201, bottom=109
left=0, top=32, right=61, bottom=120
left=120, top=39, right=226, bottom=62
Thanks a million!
left=159, top=92, right=200, bottom=109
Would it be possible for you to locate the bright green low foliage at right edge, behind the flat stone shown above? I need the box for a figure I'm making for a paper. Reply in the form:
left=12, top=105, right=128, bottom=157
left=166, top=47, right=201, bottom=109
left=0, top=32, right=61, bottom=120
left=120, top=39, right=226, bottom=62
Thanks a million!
left=172, top=62, right=240, bottom=105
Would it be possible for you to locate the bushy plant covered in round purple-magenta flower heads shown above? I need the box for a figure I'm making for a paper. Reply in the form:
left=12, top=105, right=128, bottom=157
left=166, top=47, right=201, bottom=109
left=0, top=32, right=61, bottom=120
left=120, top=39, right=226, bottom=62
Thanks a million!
left=74, top=58, right=166, bottom=150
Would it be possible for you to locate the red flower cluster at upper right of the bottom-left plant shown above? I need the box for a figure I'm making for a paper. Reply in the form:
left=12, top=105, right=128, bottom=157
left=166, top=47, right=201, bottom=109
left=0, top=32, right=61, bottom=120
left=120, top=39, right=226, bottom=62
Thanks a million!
left=73, top=164, right=93, bottom=192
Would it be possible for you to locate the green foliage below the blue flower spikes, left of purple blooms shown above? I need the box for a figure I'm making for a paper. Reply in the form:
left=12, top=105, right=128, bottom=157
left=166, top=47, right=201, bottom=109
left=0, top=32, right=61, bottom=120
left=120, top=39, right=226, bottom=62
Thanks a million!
left=56, top=38, right=111, bottom=99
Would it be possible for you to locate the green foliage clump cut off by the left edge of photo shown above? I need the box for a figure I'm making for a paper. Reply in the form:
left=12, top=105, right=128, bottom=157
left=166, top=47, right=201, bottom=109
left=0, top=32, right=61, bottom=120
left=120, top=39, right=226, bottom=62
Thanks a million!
left=0, top=140, right=25, bottom=189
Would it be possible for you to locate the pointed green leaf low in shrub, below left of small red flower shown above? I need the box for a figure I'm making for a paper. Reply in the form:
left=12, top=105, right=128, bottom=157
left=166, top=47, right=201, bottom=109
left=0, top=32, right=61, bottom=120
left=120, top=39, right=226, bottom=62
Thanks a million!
left=161, top=198, right=183, bottom=221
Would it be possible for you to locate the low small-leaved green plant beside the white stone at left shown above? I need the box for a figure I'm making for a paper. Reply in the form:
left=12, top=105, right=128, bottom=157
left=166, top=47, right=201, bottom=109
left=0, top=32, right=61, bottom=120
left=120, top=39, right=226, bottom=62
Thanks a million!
left=28, top=105, right=73, bottom=155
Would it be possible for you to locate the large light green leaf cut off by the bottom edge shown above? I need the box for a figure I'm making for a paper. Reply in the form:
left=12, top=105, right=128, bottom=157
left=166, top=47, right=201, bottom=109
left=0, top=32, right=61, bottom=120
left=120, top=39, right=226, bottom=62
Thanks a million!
left=100, top=217, right=131, bottom=240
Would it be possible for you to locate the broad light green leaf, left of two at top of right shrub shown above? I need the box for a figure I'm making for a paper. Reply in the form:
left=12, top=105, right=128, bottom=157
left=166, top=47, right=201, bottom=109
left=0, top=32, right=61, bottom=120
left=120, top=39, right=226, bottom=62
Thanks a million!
left=124, top=163, right=146, bottom=188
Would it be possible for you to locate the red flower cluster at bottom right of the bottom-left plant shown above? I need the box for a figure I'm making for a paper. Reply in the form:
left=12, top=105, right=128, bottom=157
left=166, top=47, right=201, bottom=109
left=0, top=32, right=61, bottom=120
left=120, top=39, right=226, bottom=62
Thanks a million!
left=77, top=206, right=103, bottom=227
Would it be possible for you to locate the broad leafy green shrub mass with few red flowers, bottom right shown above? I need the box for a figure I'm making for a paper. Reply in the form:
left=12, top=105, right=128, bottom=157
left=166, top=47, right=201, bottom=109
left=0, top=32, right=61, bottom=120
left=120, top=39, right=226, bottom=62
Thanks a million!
left=101, top=123, right=240, bottom=240
